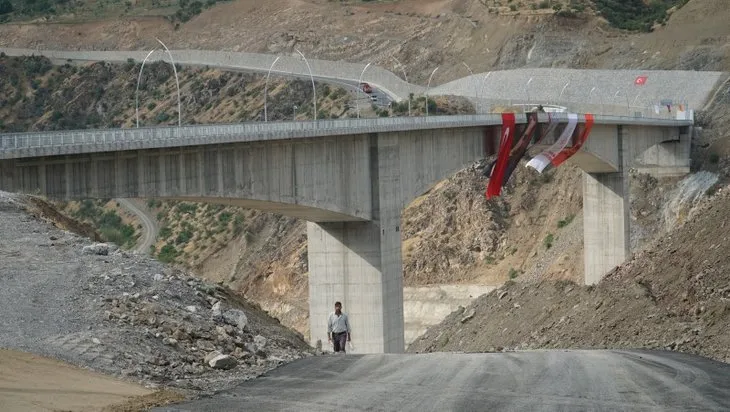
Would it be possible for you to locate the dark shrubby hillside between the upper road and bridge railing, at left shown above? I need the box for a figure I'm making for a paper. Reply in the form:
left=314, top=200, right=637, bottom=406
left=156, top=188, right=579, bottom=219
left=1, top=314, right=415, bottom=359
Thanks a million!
left=0, top=55, right=354, bottom=132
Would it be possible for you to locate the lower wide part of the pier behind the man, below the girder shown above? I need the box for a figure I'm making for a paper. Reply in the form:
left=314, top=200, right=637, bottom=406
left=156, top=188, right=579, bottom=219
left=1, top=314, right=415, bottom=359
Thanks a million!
left=307, top=222, right=405, bottom=353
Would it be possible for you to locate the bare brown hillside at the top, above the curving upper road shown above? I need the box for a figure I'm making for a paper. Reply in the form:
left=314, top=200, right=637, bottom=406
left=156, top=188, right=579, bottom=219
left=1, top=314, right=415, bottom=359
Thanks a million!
left=0, top=0, right=730, bottom=85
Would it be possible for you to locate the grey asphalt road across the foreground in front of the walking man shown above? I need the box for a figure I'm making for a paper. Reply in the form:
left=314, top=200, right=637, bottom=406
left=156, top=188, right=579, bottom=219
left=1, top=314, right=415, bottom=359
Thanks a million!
left=154, top=350, right=730, bottom=412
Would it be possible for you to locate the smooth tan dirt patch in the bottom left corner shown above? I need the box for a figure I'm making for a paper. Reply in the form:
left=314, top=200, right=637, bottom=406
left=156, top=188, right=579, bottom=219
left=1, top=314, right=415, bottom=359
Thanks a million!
left=0, top=349, right=152, bottom=412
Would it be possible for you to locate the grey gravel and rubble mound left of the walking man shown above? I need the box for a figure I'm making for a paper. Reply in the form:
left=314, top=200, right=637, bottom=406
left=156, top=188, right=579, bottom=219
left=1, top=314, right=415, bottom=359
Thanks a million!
left=0, top=192, right=312, bottom=400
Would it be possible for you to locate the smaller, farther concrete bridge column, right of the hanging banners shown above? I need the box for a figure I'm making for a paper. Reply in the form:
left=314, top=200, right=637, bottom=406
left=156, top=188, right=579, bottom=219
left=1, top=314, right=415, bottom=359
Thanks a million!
left=583, top=126, right=631, bottom=285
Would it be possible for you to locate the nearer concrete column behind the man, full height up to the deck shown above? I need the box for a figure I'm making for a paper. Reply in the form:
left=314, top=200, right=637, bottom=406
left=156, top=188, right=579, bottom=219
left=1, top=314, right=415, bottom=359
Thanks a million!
left=307, top=134, right=405, bottom=353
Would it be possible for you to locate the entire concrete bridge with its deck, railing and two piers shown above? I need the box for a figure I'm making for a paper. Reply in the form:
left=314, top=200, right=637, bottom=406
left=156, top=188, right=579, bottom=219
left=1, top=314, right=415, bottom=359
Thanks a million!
left=0, top=114, right=692, bottom=353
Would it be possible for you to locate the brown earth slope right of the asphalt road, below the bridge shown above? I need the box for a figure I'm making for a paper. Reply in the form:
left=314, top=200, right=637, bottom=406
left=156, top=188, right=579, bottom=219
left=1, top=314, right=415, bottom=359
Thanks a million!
left=409, top=180, right=730, bottom=362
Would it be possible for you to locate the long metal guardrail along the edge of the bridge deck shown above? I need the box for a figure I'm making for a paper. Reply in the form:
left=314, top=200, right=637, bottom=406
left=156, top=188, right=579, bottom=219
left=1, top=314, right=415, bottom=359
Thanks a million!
left=0, top=113, right=692, bottom=159
